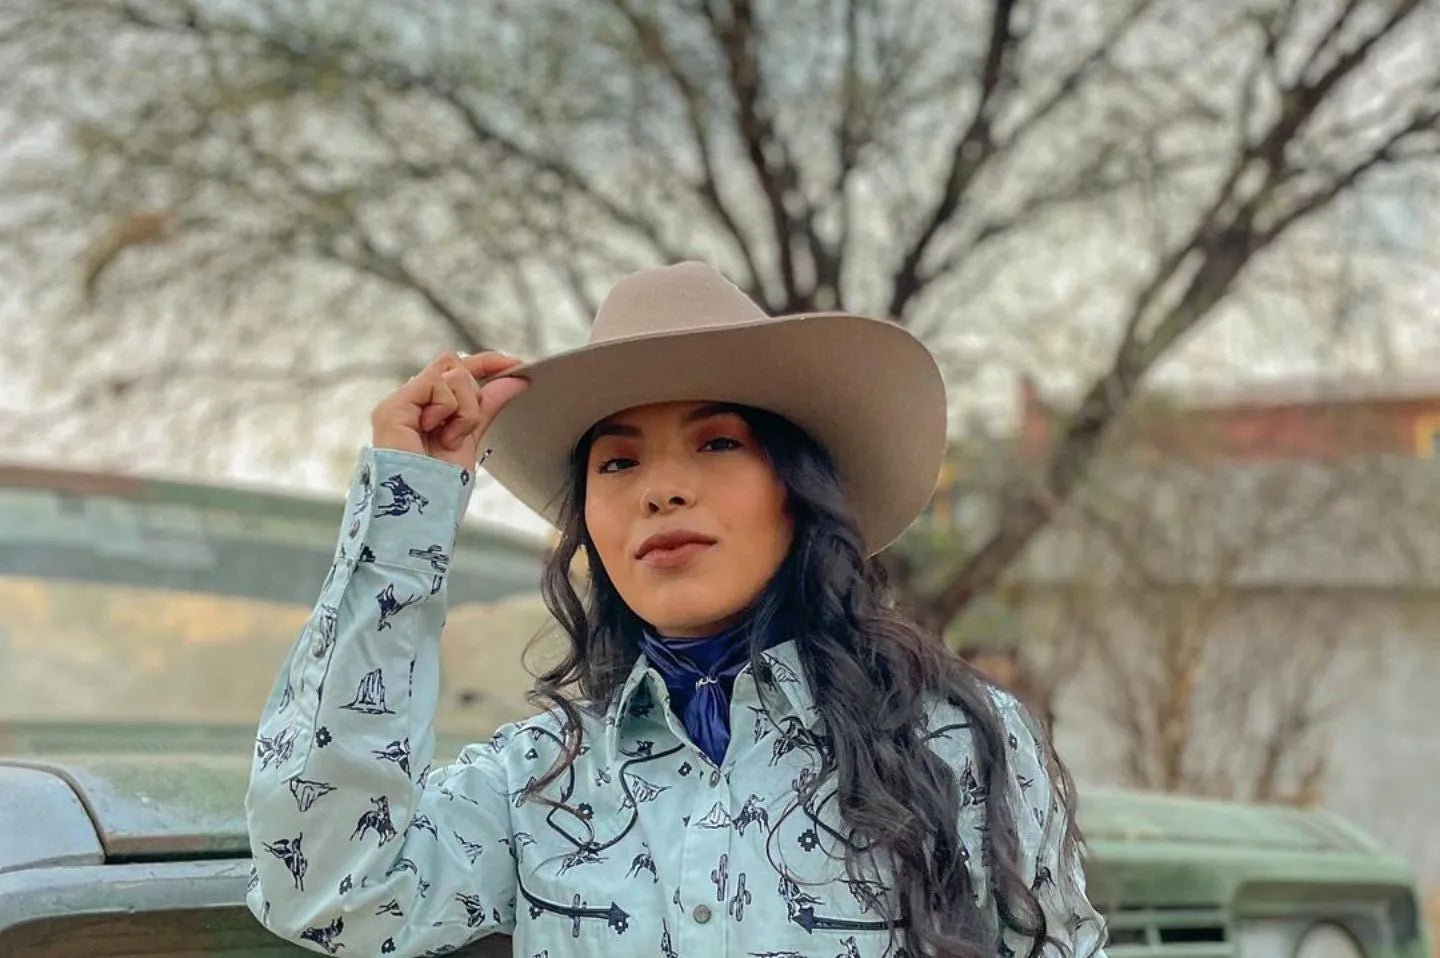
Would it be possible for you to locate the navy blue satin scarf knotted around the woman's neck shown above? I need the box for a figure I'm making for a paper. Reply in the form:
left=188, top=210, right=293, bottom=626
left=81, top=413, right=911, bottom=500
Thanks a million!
left=639, top=622, right=750, bottom=765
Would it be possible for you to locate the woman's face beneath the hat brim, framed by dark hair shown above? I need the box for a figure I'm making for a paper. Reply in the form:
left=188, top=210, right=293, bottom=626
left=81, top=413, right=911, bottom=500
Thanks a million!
left=585, top=402, right=795, bottom=638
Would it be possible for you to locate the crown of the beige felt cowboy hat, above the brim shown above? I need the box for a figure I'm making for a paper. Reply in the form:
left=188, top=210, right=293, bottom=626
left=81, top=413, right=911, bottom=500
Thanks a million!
left=589, top=262, right=770, bottom=346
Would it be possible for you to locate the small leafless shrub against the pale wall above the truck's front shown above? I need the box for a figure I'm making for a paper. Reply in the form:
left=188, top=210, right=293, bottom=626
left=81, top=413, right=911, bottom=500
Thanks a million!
left=1076, top=468, right=1341, bottom=800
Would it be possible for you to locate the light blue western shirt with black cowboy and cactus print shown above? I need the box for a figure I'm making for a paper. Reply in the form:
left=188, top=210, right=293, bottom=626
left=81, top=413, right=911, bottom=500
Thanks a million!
left=246, top=448, right=1104, bottom=958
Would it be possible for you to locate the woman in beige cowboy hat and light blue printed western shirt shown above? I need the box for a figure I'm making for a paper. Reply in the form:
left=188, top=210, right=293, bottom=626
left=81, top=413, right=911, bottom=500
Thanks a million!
left=246, top=264, right=1104, bottom=958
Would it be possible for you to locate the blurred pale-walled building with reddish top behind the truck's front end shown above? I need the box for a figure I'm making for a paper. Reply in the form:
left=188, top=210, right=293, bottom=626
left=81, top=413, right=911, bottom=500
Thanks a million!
left=919, top=371, right=1440, bottom=889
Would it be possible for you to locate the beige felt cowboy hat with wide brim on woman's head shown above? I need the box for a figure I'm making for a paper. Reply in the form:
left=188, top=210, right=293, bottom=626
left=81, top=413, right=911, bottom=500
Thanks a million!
left=484, top=262, right=946, bottom=553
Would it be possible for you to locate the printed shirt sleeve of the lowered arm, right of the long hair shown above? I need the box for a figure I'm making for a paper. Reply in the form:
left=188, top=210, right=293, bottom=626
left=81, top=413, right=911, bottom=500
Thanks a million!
left=1001, top=700, right=1106, bottom=958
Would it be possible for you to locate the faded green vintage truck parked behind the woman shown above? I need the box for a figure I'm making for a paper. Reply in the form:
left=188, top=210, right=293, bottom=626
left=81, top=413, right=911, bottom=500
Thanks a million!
left=0, top=468, right=1430, bottom=958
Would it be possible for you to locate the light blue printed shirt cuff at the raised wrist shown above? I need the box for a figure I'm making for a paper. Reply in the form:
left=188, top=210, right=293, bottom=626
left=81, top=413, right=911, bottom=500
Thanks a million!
left=338, top=445, right=475, bottom=573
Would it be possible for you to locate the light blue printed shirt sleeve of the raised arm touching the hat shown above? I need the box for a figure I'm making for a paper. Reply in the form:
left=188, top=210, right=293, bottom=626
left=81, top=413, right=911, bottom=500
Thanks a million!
left=245, top=447, right=516, bottom=958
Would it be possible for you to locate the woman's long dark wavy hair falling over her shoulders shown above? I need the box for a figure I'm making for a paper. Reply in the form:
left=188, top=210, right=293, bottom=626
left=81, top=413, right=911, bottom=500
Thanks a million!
left=530, top=406, right=1079, bottom=958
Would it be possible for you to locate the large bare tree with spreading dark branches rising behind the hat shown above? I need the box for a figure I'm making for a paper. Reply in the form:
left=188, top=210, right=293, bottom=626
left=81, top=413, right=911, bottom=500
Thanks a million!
left=0, top=0, right=1440, bottom=627
